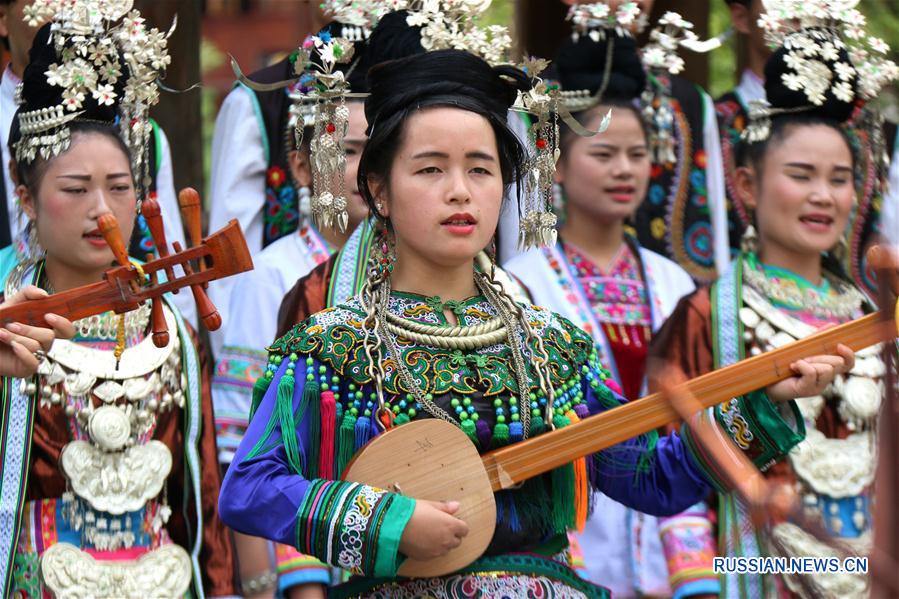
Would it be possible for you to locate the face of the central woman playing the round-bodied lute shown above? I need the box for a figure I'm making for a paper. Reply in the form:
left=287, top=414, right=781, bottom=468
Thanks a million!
left=369, top=107, right=503, bottom=267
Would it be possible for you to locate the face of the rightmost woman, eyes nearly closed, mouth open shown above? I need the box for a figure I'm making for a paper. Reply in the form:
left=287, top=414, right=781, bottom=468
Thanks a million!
left=741, top=125, right=855, bottom=254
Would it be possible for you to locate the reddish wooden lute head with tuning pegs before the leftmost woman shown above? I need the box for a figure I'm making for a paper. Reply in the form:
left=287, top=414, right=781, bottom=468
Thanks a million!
left=0, top=188, right=253, bottom=338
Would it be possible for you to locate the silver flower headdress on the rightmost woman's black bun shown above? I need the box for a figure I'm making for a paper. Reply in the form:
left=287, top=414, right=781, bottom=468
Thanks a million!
left=743, top=0, right=899, bottom=142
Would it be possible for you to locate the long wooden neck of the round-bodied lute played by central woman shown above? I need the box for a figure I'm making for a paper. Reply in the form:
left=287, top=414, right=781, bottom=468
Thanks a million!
left=482, top=310, right=899, bottom=491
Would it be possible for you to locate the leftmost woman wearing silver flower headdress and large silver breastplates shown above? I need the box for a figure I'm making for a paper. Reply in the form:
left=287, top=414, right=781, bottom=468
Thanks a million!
left=0, top=7, right=235, bottom=597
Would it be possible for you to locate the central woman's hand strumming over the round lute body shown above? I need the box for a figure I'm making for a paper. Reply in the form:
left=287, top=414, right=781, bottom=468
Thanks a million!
left=400, top=499, right=468, bottom=560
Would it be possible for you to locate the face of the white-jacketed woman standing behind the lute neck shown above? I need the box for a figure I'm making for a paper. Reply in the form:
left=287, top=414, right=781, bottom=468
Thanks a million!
left=556, top=106, right=652, bottom=222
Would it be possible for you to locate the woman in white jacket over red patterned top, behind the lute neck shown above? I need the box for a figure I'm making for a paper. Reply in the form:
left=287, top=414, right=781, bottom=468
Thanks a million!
left=504, top=18, right=694, bottom=598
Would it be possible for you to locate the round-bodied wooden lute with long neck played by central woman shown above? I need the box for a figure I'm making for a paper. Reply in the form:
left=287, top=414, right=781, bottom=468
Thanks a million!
left=343, top=248, right=899, bottom=577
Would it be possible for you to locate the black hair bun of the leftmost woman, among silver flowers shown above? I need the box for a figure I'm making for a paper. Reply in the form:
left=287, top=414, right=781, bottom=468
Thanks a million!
left=19, top=23, right=128, bottom=123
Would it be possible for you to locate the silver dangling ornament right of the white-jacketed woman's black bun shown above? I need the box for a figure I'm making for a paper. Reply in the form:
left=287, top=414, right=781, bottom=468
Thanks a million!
left=641, top=12, right=722, bottom=163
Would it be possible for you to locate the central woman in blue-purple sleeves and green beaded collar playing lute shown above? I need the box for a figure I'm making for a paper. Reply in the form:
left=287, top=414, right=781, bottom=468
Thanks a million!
left=219, top=50, right=851, bottom=597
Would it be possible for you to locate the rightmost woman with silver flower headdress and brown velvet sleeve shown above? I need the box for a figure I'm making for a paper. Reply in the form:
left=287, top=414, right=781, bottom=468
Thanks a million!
left=650, top=1, right=897, bottom=598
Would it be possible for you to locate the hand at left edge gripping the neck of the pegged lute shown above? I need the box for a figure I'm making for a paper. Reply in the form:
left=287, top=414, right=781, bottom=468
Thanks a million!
left=0, top=285, right=75, bottom=378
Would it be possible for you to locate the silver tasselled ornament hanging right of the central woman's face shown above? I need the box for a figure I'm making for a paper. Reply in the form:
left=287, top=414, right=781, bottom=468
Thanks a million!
left=512, top=58, right=612, bottom=249
